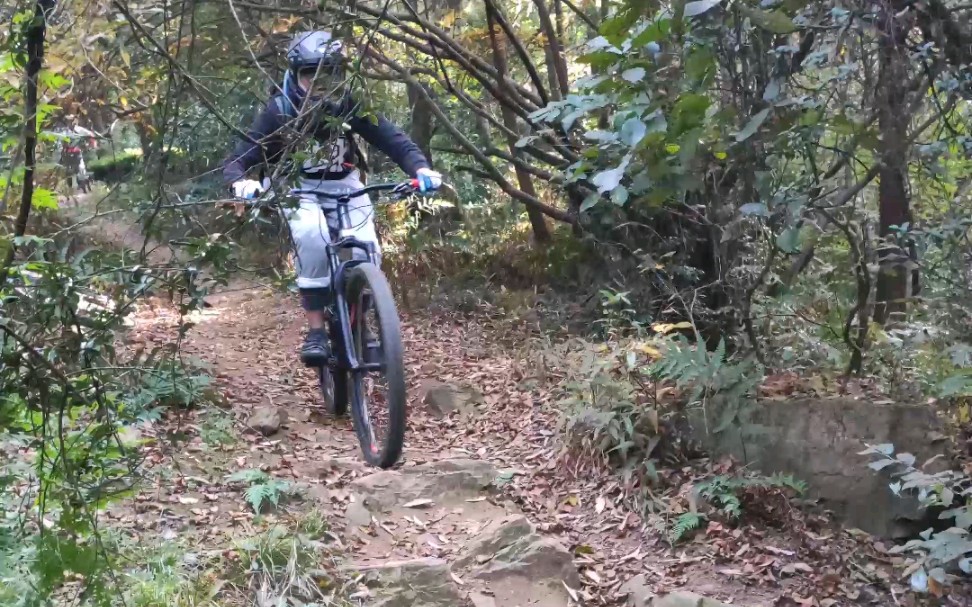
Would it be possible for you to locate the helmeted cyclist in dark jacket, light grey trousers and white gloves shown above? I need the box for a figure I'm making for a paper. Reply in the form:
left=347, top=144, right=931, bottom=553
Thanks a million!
left=223, top=31, right=442, bottom=366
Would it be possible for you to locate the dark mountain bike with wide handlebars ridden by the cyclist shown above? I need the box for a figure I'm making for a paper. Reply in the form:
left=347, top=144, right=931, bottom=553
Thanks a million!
left=247, top=180, right=418, bottom=468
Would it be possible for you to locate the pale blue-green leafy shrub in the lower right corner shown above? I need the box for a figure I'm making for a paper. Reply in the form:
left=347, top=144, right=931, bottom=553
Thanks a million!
left=860, top=444, right=972, bottom=592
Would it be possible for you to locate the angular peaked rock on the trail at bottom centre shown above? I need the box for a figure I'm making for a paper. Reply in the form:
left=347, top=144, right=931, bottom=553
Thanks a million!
left=473, top=533, right=580, bottom=588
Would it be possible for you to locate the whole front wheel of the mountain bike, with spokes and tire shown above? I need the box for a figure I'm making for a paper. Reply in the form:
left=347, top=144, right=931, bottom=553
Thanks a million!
left=345, top=263, right=406, bottom=468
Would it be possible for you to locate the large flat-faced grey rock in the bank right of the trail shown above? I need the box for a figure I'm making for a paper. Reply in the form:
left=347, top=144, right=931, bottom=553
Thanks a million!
left=692, top=398, right=944, bottom=536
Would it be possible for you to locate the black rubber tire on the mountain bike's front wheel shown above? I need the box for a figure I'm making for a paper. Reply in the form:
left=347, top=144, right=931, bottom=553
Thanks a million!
left=345, top=263, right=406, bottom=468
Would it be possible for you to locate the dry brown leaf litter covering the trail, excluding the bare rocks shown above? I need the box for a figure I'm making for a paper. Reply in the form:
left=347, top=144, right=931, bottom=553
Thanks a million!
left=95, top=282, right=960, bottom=607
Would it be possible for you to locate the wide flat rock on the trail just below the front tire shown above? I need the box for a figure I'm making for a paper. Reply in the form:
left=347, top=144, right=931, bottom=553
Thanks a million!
left=350, top=459, right=496, bottom=512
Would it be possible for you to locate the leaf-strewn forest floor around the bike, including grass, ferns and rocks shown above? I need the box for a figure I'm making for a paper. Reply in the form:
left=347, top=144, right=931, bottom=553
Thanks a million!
left=74, top=194, right=940, bottom=607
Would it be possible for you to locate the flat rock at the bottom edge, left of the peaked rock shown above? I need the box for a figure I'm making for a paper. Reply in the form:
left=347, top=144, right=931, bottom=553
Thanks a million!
left=356, top=558, right=463, bottom=607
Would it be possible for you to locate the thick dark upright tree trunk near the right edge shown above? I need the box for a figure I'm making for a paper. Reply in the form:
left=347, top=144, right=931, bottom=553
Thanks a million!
left=874, top=0, right=911, bottom=325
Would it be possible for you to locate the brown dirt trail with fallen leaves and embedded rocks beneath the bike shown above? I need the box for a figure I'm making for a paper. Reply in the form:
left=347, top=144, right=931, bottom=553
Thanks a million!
left=87, top=196, right=900, bottom=607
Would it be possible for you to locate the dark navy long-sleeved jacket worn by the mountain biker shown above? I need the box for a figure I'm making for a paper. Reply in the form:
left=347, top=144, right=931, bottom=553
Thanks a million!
left=223, top=95, right=429, bottom=184
